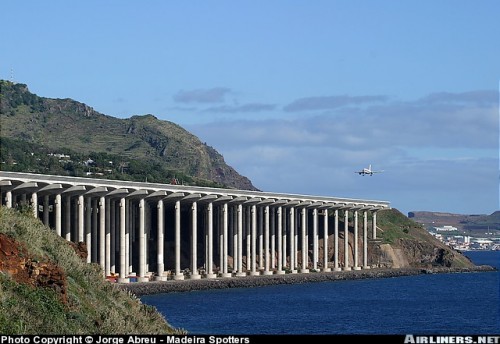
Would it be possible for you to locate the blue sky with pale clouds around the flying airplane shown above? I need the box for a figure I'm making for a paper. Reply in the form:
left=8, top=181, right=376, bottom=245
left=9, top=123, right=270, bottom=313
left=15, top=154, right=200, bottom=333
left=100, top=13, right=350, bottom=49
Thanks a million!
left=0, top=0, right=500, bottom=214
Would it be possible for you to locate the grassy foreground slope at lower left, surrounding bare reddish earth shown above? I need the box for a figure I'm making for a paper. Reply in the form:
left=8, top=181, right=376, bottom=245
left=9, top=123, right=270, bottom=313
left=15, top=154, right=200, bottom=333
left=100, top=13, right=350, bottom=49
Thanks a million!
left=0, top=207, right=184, bottom=334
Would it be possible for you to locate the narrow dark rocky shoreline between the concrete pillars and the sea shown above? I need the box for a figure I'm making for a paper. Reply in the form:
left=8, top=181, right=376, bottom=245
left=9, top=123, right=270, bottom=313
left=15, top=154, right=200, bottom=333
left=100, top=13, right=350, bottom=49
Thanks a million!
left=115, top=265, right=498, bottom=297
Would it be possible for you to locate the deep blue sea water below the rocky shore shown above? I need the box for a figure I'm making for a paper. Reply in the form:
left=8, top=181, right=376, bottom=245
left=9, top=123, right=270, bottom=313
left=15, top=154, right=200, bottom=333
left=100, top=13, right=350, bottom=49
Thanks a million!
left=141, top=251, right=500, bottom=335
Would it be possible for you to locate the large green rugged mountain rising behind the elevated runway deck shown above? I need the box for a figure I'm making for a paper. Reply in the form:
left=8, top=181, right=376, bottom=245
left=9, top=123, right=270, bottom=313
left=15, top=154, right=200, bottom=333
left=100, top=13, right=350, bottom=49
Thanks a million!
left=0, top=80, right=257, bottom=190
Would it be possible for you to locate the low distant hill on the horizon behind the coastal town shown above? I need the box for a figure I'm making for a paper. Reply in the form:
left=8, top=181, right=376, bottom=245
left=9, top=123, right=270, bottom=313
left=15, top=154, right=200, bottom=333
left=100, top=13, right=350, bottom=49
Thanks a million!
left=408, top=211, right=500, bottom=231
